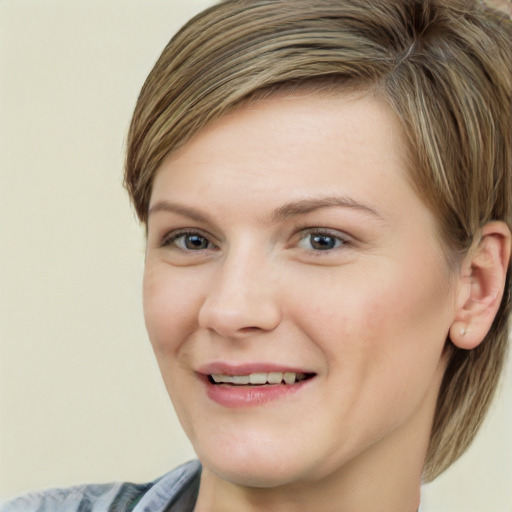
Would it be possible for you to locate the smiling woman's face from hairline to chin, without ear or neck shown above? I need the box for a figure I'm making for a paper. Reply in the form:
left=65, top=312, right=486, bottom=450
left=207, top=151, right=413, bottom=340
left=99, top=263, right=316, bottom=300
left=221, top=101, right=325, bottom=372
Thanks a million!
left=144, top=95, right=457, bottom=487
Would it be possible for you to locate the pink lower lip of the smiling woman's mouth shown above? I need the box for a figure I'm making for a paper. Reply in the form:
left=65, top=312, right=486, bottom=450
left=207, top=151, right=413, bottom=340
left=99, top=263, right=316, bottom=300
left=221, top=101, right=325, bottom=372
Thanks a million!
left=205, top=377, right=313, bottom=408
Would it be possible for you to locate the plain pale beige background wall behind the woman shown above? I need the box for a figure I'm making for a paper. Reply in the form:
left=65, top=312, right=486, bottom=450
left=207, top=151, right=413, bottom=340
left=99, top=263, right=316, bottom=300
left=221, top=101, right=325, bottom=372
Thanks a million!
left=0, top=0, right=512, bottom=512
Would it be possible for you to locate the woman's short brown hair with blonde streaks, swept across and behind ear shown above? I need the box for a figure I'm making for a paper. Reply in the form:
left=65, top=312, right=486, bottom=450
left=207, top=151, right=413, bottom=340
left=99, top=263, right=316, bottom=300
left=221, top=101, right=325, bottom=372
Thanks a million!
left=125, top=0, right=512, bottom=481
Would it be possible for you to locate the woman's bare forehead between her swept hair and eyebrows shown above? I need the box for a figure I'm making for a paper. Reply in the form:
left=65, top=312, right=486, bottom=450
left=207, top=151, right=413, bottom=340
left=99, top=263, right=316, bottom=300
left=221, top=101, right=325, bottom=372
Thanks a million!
left=151, top=91, right=409, bottom=210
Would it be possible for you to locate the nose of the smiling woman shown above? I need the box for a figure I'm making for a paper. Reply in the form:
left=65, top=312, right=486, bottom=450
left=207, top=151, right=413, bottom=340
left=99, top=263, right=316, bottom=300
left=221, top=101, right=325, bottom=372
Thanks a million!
left=199, top=251, right=281, bottom=338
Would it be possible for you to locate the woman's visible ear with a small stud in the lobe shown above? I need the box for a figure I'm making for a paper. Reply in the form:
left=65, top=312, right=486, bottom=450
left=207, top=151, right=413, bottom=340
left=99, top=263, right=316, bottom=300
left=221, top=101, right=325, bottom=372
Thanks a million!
left=450, top=222, right=511, bottom=350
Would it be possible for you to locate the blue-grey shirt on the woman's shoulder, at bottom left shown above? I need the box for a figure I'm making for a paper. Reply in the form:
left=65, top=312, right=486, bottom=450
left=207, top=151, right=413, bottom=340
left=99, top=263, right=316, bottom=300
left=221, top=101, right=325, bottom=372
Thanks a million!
left=0, top=461, right=201, bottom=512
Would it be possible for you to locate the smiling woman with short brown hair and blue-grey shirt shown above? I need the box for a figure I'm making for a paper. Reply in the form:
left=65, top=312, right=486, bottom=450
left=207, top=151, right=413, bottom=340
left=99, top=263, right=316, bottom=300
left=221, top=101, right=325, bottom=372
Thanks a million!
left=6, top=0, right=512, bottom=512
